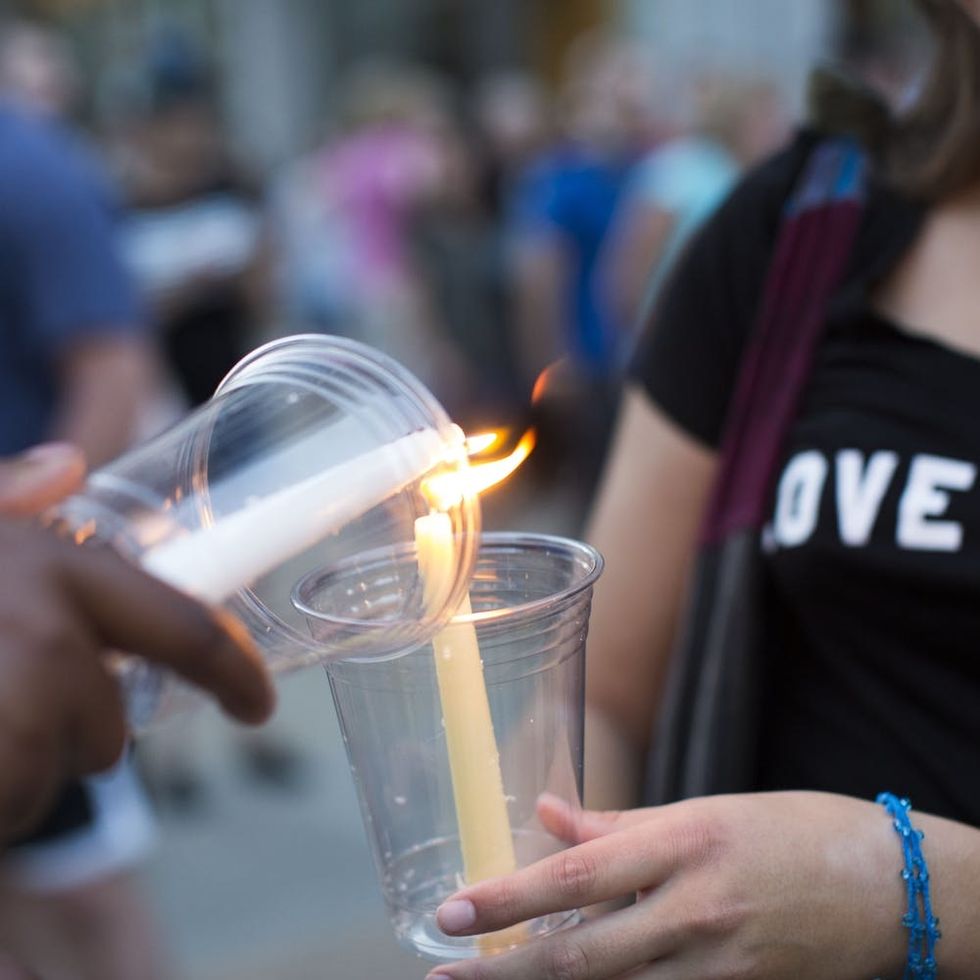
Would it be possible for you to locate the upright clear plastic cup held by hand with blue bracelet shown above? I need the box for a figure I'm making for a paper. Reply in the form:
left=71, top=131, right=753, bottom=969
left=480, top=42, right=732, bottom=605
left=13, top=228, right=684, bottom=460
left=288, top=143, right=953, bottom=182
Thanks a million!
left=295, top=534, right=602, bottom=961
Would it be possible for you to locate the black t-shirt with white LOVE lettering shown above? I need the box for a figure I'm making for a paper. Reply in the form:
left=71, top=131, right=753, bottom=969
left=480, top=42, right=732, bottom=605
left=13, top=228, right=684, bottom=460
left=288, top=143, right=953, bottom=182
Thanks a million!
left=633, top=128, right=980, bottom=825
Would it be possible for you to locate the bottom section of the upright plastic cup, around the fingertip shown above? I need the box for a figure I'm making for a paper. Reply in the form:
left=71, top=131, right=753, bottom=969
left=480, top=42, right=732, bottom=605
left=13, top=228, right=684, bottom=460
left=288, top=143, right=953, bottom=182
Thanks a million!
left=385, top=831, right=580, bottom=963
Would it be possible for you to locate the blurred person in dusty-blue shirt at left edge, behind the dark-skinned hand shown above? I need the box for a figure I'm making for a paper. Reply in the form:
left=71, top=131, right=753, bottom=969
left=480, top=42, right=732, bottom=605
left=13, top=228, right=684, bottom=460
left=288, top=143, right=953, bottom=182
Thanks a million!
left=0, top=15, right=168, bottom=980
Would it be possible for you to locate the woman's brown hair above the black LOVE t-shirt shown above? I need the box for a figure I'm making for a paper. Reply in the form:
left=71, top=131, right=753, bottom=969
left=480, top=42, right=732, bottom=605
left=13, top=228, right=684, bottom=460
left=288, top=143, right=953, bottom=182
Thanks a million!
left=810, top=0, right=980, bottom=203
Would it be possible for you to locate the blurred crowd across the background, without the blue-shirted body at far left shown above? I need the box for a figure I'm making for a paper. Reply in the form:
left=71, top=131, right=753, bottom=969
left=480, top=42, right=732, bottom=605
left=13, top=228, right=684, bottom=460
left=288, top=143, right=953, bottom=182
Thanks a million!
left=0, top=16, right=788, bottom=470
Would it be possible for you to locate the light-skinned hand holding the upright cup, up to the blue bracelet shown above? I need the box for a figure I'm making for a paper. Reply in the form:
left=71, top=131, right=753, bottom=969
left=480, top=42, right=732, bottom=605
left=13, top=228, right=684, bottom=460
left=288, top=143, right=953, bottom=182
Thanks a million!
left=429, top=793, right=906, bottom=980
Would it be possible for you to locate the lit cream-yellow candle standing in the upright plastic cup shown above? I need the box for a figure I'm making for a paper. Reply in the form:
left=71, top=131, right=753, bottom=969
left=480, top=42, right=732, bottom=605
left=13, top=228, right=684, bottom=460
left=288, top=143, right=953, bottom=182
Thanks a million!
left=415, top=513, right=524, bottom=950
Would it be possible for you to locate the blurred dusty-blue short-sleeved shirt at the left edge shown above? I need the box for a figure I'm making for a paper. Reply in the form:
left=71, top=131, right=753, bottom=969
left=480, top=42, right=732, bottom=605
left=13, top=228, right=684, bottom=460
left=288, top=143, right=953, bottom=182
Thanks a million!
left=0, top=105, right=143, bottom=455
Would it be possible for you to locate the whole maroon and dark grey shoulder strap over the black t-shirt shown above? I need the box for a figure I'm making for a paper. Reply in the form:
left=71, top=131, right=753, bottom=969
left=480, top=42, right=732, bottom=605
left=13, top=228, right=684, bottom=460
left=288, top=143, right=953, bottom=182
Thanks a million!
left=647, top=141, right=866, bottom=803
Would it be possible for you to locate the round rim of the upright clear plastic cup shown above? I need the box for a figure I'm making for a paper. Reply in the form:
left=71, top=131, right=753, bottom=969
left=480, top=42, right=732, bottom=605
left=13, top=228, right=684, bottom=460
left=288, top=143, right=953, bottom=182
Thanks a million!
left=291, top=531, right=605, bottom=630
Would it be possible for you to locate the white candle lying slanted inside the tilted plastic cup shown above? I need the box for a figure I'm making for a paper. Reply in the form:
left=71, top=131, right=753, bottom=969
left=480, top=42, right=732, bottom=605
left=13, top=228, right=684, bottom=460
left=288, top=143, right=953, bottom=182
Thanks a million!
left=142, top=429, right=446, bottom=602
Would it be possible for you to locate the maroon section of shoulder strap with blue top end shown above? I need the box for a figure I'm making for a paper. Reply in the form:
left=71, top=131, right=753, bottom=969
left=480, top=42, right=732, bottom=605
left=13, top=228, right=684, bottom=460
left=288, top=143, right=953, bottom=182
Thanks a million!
left=702, top=139, right=868, bottom=544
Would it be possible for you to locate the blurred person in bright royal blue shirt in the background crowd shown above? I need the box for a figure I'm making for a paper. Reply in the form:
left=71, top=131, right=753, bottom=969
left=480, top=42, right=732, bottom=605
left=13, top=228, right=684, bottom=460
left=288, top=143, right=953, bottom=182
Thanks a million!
left=507, top=33, right=657, bottom=510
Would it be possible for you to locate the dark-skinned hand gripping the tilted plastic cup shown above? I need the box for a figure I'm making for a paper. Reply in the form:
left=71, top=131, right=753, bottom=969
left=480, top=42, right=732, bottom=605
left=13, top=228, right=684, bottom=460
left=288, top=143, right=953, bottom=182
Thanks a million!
left=0, top=445, right=275, bottom=847
